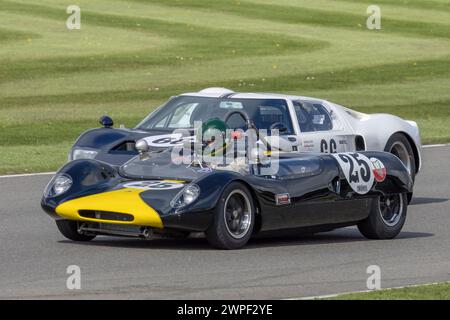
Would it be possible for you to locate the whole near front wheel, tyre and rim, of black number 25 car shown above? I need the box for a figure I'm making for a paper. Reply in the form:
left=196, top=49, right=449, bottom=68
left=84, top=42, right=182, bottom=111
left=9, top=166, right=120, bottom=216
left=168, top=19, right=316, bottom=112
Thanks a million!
left=206, top=182, right=255, bottom=249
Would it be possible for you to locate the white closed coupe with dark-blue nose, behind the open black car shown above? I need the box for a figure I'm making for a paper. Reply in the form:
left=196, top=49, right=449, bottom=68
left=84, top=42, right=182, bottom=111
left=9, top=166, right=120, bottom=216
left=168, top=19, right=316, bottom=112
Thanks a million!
left=69, top=88, right=421, bottom=178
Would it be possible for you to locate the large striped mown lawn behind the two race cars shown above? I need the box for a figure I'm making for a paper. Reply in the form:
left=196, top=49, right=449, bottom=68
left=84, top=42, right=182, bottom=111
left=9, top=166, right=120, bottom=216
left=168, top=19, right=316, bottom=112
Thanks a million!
left=0, top=0, right=450, bottom=174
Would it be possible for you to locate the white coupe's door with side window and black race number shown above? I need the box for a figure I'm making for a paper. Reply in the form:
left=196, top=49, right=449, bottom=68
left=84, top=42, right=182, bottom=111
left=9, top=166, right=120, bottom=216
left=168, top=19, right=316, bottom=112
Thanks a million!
left=292, top=100, right=354, bottom=153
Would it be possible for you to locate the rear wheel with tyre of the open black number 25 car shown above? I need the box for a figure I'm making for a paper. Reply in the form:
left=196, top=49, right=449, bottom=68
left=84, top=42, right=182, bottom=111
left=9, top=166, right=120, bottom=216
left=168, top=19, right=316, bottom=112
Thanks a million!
left=358, top=193, right=408, bottom=239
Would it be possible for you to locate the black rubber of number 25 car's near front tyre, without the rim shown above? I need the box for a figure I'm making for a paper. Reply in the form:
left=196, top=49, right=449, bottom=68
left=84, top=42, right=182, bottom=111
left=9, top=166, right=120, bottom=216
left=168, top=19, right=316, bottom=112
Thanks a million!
left=206, top=182, right=255, bottom=249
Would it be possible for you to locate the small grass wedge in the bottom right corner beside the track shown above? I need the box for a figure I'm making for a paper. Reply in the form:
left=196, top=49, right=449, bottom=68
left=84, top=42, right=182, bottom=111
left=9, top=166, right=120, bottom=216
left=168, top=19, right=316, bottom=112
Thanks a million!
left=330, top=283, right=450, bottom=300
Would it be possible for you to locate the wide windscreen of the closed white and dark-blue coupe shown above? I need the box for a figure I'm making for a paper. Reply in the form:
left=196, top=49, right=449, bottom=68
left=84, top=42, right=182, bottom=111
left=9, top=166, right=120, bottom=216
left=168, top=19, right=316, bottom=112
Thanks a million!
left=137, top=96, right=293, bottom=134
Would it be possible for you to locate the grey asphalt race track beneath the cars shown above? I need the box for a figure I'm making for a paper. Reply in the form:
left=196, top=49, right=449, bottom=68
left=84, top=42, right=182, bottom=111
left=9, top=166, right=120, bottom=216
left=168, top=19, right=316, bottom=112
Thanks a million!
left=0, top=147, right=450, bottom=299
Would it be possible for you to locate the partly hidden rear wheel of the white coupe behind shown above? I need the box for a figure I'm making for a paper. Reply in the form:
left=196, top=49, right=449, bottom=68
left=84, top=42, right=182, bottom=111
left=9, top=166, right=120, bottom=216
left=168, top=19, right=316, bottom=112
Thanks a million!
left=384, top=133, right=416, bottom=181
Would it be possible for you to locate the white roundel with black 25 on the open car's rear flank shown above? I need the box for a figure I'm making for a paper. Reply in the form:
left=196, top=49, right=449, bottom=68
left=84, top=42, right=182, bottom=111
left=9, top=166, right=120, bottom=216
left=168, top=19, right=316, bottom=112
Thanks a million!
left=331, top=152, right=375, bottom=194
